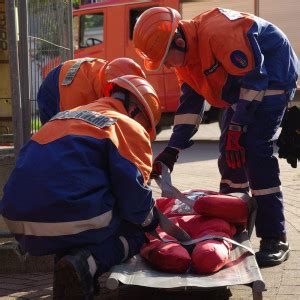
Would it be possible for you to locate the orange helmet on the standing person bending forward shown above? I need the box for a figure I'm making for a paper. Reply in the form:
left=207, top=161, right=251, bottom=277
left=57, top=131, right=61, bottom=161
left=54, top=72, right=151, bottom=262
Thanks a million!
left=133, top=7, right=181, bottom=71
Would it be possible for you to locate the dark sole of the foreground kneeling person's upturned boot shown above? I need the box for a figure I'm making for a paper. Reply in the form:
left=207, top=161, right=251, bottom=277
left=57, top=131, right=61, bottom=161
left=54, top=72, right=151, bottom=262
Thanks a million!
left=53, top=258, right=93, bottom=300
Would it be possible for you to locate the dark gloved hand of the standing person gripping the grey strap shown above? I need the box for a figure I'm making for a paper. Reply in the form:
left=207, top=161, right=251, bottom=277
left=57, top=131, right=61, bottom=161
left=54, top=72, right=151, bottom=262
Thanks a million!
left=150, top=147, right=179, bottom=179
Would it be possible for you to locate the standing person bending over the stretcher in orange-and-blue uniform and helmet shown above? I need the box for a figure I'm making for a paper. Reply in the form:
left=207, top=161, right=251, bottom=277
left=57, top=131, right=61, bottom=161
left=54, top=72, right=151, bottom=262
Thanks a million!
left=134, top=7, right=298, bottom=266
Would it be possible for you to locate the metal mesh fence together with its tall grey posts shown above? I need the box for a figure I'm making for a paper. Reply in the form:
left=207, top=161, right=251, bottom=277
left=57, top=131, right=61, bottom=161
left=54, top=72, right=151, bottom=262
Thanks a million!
left=0, top=0, right=73, bottom=154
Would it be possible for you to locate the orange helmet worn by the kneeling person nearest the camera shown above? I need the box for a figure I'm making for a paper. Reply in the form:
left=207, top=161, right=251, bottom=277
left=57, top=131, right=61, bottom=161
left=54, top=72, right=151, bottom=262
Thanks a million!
left=104, top=75, right=161, bottom=141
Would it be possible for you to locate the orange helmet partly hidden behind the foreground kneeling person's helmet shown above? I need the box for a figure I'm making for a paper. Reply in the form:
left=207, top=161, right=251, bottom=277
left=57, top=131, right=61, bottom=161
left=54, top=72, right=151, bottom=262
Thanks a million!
left=103, top=57, right=146, bottom=86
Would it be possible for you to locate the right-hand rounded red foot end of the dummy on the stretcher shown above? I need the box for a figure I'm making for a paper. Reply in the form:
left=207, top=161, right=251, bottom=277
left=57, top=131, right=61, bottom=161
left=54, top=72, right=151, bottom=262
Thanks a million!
left=191, top=240, right=230, bottom=274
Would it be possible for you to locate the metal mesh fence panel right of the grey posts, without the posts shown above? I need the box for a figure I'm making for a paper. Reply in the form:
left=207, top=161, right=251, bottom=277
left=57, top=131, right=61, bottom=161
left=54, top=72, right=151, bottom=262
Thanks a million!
left=28, top=0, right=73, bottom=132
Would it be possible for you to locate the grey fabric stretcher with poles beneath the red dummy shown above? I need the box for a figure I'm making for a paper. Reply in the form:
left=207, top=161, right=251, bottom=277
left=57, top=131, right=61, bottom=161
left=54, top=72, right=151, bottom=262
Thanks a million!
left=106, top=168, right=265, bottom=300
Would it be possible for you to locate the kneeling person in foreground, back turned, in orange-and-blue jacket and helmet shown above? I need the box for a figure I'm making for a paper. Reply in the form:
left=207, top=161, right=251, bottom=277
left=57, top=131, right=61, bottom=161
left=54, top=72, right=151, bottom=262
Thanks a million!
left=0, top=75, right=160, bottom=299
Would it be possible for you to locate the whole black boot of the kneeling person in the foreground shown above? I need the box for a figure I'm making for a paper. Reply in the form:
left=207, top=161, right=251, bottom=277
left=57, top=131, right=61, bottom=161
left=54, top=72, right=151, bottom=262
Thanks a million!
left=53, top=249, right=94, bottom=300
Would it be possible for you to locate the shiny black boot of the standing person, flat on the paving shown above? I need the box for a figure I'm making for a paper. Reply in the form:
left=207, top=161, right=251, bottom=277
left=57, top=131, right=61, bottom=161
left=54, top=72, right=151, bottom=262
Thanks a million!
left=255, top=239, right=290, bottom=267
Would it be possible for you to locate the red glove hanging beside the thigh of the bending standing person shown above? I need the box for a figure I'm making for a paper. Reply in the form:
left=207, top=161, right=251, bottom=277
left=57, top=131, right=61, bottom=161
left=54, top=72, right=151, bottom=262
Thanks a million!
left=225, top=123, right=246, bottom=169
